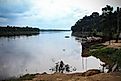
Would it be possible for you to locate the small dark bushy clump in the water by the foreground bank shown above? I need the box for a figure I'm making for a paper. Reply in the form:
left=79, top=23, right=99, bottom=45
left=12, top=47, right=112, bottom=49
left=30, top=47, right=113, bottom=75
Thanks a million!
left=55, top=61, right=70, bottom=73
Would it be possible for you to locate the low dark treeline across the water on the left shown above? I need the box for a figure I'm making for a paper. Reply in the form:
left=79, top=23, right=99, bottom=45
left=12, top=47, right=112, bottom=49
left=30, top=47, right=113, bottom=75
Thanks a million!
left=0, top=25, right=40, bottom=36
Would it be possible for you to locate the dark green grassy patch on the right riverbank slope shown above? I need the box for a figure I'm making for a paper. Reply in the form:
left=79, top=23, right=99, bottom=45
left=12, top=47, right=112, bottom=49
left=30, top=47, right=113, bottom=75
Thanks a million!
left=89, top=47, right=121, bottom=67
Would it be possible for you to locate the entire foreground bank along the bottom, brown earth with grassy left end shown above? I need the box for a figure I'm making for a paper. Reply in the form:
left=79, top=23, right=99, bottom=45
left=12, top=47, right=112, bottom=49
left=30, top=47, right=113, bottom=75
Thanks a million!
left=4, top=71, right=121, bottom=81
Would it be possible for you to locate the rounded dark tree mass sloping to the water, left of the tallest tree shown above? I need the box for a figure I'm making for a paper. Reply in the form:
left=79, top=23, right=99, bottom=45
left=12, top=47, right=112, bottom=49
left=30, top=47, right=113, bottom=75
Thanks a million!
left=71, top=12, right=99, bottom=32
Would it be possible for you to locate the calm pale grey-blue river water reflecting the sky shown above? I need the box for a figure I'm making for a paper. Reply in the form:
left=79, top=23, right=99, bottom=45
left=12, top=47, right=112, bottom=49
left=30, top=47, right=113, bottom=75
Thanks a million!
left=0, top=31, right=101, bottom=79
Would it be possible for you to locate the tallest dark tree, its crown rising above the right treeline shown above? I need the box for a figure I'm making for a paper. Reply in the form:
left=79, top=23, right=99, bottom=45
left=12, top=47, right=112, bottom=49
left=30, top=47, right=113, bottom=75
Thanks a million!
left=102, top=5, right=115, bottom=44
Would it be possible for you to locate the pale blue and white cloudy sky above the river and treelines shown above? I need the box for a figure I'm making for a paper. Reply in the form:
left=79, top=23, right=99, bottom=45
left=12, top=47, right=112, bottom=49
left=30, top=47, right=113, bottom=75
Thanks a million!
left=0, top=0, right=121, bottom=29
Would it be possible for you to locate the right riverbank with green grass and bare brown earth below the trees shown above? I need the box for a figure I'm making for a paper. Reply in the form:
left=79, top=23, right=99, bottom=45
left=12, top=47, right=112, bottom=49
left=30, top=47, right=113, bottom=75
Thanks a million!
left=82, top=37, right=121, bottom=72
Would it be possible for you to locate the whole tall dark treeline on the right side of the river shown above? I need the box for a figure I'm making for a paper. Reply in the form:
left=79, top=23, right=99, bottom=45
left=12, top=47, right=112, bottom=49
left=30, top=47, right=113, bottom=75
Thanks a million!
left=71, top=5, right=121, bottom=41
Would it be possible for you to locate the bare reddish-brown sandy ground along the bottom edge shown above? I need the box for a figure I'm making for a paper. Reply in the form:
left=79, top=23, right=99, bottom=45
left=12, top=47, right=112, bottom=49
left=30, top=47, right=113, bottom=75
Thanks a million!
left=31, top=73, right=121, bottom=81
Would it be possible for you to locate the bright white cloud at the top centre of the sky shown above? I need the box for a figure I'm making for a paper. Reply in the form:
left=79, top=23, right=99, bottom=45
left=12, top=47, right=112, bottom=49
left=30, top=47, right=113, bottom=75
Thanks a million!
left=27, top=0, right=89, bottom=20
